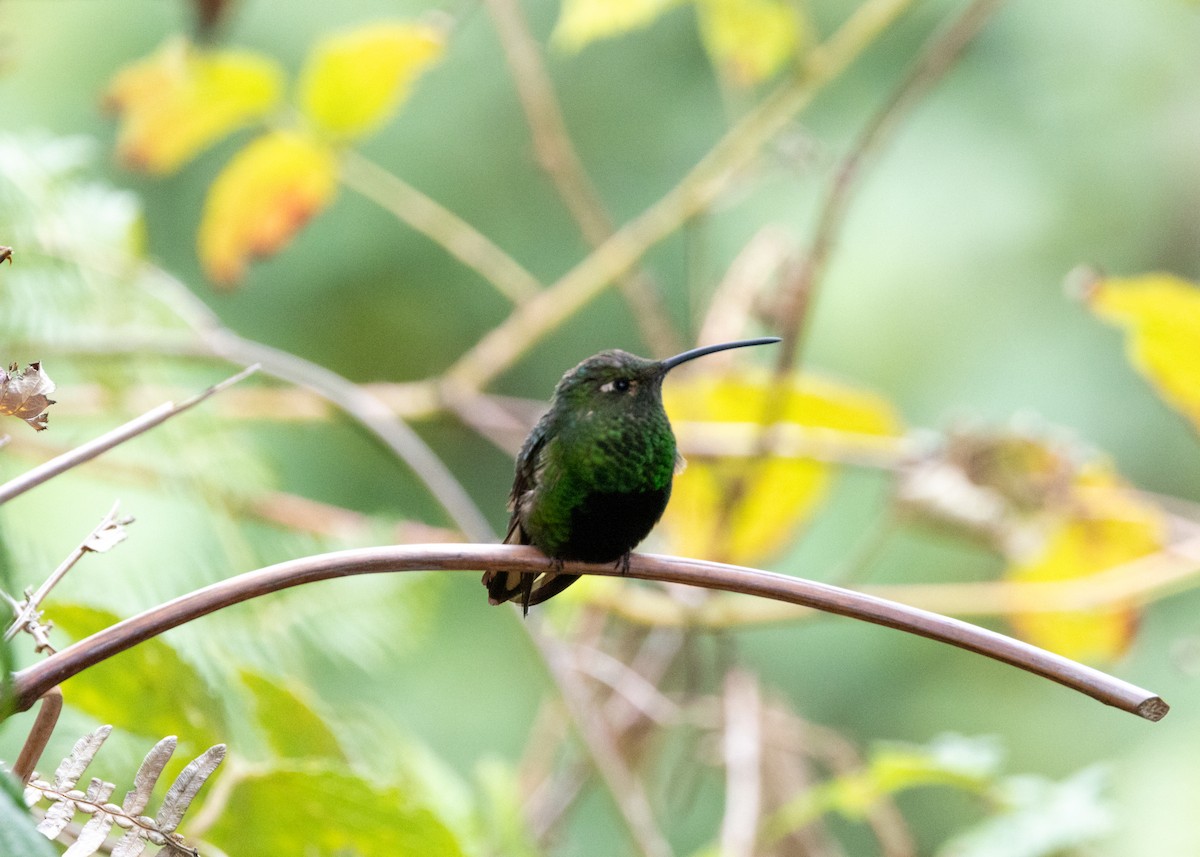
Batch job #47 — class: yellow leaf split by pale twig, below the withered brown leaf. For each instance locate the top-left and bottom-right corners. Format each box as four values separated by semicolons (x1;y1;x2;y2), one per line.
1006;462;1166;661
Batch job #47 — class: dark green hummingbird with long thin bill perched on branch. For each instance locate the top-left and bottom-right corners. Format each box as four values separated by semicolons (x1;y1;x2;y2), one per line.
484;336;779;615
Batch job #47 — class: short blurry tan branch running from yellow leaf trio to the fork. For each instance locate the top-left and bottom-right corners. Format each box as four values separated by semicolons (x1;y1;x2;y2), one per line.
342;149;542;305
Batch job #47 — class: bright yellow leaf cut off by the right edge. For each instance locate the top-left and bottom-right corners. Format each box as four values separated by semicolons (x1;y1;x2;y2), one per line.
1088;274;1200;431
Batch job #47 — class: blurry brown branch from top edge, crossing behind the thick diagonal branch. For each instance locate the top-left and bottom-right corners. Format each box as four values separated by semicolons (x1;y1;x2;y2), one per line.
486;0;683;356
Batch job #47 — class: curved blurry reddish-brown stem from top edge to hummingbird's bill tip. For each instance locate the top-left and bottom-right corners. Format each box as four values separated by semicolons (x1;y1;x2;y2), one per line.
776;0;1003;373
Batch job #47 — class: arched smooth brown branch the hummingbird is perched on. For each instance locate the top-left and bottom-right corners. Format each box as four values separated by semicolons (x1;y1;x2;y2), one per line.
12;545;1168;720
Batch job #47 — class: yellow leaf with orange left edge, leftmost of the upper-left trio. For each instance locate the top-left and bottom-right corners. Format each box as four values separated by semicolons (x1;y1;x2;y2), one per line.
104;38;283;174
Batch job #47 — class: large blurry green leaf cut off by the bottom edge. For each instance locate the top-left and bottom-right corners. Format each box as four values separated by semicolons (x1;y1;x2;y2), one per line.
205;765;466;857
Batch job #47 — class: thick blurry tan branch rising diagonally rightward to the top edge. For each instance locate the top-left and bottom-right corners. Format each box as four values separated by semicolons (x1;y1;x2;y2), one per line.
445;0;912;390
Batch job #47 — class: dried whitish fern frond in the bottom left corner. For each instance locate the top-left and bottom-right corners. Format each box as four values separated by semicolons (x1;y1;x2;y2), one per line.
25;726;226;857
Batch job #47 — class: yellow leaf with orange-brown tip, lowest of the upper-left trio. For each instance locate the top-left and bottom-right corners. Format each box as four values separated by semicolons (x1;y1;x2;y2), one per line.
198;131;337;286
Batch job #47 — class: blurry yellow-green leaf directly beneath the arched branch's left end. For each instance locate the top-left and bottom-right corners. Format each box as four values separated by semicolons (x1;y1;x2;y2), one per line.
47;604;227;748
